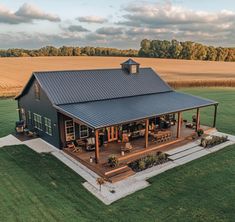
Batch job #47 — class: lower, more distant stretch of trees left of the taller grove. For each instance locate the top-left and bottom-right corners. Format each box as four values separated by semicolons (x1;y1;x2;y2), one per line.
0;46;138;57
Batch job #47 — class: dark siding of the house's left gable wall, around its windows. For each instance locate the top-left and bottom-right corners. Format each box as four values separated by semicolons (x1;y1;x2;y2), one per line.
18;79;60;148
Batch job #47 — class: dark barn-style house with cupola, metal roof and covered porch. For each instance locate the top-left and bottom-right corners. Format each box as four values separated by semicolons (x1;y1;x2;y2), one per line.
16;59;218;182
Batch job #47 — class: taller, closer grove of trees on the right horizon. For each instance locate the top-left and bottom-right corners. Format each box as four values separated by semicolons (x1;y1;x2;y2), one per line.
138;39;235;61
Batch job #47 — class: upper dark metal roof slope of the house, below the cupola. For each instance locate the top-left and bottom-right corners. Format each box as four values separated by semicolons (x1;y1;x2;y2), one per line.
34;68;172;105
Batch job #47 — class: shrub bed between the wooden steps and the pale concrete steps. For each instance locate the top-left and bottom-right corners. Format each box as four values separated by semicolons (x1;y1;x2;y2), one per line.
128;152;169;172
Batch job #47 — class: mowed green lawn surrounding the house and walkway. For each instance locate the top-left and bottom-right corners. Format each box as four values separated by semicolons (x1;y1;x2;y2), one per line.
0;89;235;222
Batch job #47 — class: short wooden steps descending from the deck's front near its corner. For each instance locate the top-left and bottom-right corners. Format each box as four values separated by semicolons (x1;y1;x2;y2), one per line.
107;166;135;183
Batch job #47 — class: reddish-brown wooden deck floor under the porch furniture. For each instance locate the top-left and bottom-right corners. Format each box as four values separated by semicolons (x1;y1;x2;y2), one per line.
64;126;209;182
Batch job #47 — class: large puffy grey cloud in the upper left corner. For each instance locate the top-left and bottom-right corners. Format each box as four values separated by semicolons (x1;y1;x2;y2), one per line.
0;3;60;24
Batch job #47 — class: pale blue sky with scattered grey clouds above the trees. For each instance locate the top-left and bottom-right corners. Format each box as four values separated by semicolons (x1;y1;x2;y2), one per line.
0;0;235;49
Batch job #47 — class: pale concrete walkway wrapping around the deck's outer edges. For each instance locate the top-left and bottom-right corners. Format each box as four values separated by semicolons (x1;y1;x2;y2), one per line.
0;132;235;205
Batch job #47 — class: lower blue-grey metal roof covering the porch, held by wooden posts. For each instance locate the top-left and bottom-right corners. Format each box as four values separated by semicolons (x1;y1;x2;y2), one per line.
55;91;217;129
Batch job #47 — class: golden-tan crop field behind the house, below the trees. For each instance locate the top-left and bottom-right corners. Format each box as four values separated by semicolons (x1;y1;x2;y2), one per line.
0;57;235;96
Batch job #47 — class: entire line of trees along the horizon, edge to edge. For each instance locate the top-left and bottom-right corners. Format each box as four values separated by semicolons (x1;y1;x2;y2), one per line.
0;39;235;61
